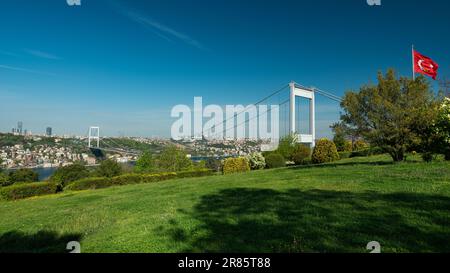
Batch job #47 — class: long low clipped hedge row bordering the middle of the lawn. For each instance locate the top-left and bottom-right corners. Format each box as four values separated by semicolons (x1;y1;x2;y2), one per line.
64;169;213;191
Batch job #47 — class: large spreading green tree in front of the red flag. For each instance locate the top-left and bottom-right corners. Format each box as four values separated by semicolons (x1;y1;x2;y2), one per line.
341;69;436;162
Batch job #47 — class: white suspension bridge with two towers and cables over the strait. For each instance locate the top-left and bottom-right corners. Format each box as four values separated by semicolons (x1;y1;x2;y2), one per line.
88;79;342;156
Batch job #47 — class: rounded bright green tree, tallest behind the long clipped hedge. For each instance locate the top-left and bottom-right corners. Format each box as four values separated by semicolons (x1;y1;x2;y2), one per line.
157;145;193;172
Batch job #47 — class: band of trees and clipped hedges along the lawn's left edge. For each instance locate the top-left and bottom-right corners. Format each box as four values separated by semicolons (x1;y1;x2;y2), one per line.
0;145;213;200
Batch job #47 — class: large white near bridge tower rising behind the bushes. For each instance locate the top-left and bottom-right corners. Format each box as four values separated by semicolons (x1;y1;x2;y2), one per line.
289;82;316;148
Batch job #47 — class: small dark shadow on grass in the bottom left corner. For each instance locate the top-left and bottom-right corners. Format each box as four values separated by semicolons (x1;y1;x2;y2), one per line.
0;231;81;253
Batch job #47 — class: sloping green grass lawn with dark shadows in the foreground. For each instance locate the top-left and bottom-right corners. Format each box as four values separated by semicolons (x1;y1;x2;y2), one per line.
0;156;450;252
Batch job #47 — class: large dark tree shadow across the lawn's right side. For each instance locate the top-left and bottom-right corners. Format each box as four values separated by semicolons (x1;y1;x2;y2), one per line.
158;188;450;252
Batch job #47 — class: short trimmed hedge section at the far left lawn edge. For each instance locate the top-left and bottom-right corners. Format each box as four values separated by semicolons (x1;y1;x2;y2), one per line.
0;182;56;200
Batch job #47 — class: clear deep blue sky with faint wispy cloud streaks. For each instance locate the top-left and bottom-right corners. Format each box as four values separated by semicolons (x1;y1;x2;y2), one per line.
0;0;450;137
